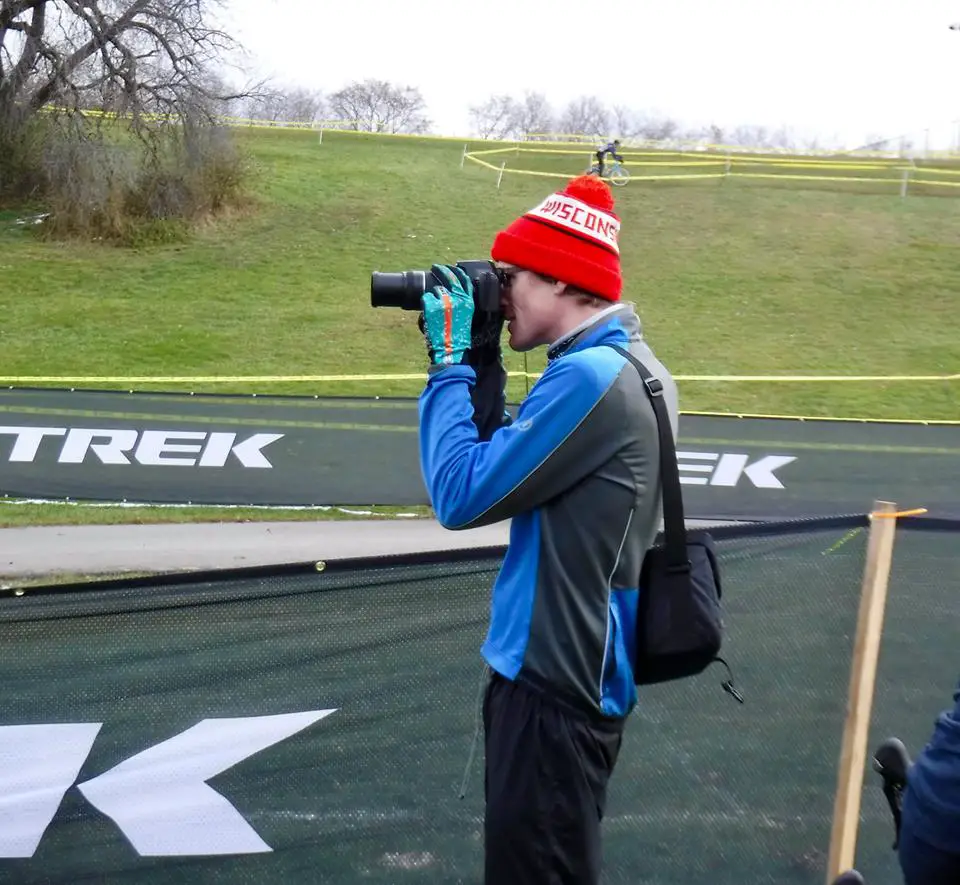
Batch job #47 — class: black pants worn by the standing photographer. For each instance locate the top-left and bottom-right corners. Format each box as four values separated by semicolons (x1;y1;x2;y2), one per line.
483;674;624;885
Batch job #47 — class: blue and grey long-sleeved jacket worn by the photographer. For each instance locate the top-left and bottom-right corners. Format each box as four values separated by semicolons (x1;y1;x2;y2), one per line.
420;304;677;717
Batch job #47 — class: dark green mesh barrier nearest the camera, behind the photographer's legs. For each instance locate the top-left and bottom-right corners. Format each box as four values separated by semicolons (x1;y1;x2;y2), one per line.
0;516;960;885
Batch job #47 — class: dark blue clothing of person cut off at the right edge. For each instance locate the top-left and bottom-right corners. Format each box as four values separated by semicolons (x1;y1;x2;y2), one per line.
903;672;960;855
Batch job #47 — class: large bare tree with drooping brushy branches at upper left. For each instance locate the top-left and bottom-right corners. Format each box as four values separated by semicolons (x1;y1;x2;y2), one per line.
0;0;253;235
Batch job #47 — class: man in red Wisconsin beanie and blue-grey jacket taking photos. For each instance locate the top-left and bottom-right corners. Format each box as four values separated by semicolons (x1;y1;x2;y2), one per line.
420;176;677;885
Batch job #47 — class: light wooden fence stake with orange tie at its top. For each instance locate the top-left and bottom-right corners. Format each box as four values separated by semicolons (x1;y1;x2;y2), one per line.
827;501;897;883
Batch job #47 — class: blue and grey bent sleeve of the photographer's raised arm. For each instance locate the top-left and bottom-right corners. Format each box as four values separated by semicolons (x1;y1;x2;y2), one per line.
420;348;624;529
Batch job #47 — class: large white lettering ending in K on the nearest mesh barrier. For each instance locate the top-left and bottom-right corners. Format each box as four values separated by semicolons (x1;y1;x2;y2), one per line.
0;710;336;857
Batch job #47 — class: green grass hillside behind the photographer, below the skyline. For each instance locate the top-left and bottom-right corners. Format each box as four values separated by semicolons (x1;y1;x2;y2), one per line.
0;130;960;520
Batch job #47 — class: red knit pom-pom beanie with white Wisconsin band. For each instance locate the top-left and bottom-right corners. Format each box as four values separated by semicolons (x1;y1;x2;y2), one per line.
490;175;623;301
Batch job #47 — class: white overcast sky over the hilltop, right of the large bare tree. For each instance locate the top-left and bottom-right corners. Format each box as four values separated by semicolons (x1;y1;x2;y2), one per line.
225;0;960;147
